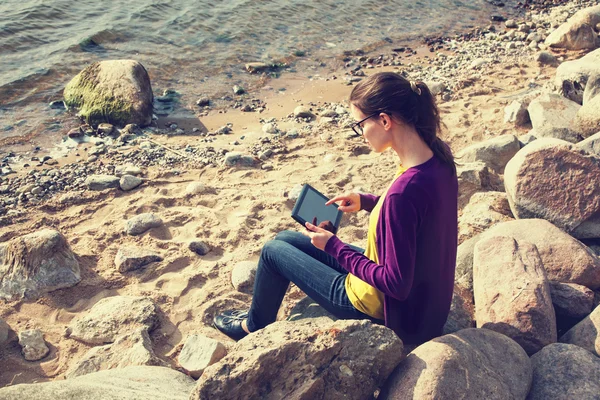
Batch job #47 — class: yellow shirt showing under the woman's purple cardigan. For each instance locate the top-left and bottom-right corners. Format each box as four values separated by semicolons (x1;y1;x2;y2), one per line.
345;166;406;319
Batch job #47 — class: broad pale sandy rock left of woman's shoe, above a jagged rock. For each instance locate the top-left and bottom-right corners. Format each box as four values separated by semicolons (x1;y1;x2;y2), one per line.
69;296;158;345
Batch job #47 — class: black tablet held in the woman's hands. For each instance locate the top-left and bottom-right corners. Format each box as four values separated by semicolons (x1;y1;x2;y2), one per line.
292;184;343;233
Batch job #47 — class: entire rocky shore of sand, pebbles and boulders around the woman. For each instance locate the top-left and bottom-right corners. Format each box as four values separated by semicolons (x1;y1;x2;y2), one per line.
0;1;600;399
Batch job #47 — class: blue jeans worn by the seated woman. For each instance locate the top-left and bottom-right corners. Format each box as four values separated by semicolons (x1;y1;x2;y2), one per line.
247;231;382;332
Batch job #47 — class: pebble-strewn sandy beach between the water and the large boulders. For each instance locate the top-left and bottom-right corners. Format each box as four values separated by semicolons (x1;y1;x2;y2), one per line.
0;2;589;387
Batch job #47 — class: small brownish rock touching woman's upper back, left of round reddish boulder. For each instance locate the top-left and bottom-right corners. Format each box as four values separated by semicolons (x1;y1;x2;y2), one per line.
457;162;502;209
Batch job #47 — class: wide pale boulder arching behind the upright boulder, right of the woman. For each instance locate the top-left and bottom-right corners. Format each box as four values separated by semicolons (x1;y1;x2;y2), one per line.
456;219;600;289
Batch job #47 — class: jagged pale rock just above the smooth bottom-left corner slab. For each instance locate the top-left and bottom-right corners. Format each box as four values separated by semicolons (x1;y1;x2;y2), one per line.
66;329;168;379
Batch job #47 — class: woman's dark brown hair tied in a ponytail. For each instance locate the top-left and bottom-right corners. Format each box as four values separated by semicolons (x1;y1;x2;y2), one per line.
350;72;456;175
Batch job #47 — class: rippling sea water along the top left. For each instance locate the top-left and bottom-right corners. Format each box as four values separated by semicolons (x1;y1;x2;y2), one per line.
0;0;511;148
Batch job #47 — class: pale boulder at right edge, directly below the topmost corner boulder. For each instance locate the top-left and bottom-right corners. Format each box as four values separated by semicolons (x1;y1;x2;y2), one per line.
554;49;600;104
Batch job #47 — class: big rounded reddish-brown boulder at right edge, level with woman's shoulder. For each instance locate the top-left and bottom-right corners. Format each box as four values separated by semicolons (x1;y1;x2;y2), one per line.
504;138;600;238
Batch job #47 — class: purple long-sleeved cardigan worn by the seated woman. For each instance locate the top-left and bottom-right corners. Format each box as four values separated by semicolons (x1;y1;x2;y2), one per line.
325;156;458;343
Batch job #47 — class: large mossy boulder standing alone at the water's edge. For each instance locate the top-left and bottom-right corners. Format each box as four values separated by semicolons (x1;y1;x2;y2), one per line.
64;60;154;126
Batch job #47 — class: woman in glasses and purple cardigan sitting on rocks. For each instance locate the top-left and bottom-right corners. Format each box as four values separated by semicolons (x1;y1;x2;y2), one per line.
215;73;458;344
